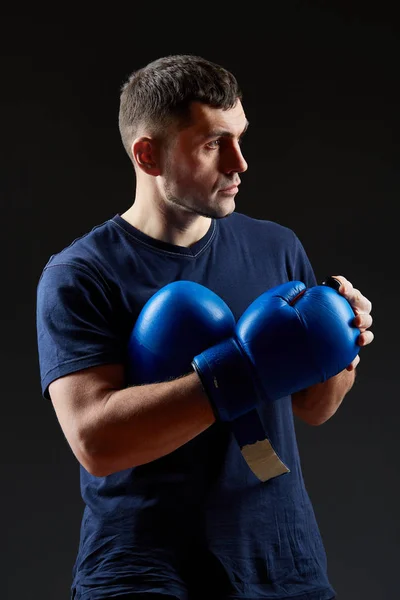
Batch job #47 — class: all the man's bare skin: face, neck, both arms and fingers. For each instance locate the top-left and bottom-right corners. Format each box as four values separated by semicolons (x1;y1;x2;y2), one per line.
49;101;374;477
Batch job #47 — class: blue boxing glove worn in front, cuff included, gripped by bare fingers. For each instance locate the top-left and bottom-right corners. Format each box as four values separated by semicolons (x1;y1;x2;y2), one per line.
192;281;360;421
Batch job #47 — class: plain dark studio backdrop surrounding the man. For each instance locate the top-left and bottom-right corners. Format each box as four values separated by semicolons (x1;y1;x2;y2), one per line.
0;1;400;600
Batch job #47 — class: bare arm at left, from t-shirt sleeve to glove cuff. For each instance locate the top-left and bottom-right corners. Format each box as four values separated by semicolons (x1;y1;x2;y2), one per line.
49;365;215;477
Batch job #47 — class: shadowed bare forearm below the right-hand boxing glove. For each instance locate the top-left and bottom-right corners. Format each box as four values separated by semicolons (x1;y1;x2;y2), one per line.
292;369;356;425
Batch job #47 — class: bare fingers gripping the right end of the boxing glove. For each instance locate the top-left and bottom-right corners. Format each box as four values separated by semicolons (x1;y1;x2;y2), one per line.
326;275;374;371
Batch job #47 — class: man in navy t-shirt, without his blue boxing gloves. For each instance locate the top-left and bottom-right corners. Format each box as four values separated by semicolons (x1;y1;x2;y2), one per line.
37;56;373;600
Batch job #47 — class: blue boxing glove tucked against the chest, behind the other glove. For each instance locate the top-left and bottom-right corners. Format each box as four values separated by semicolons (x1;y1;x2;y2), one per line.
127;281;266;469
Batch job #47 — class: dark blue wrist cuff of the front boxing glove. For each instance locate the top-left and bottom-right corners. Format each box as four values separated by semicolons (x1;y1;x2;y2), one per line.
192;338;257;421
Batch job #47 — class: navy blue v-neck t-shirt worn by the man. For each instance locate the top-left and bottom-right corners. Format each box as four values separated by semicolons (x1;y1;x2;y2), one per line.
37;212;334;600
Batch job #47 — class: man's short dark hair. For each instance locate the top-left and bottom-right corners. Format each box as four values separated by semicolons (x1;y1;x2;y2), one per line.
115;54;242;160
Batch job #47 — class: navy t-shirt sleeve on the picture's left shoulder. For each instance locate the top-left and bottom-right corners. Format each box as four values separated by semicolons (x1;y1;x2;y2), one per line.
36;264;124;399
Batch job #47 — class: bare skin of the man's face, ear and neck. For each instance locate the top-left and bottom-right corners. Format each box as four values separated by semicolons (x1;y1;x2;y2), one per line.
122;102;248;247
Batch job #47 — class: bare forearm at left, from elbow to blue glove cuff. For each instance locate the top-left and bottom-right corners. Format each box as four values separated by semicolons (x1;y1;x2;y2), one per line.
87;373;215;476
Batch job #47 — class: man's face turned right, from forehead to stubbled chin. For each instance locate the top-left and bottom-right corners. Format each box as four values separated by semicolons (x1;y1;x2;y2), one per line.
158;100;248;218
